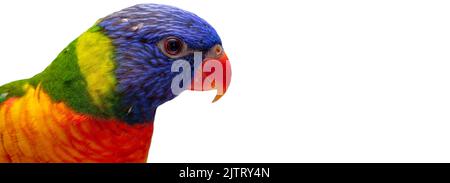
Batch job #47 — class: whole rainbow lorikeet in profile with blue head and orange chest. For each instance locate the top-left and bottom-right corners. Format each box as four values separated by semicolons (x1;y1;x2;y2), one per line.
0;4;231;162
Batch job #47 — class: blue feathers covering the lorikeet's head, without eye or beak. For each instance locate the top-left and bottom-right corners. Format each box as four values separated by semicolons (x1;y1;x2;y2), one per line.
98;4;221;124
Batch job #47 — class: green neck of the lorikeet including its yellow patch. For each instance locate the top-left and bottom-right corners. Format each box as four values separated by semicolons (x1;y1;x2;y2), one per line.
23;26;132;122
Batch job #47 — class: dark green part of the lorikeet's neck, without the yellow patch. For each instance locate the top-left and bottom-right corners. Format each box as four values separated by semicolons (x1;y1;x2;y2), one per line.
27;38;117;118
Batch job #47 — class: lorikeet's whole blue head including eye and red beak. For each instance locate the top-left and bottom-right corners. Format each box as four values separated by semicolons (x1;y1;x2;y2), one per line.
89;4;231;123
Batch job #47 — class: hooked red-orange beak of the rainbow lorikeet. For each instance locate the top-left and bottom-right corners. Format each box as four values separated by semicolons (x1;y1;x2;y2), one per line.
188;45;231;103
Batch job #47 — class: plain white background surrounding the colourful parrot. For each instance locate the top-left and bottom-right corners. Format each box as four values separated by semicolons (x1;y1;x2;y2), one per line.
0;0;450;162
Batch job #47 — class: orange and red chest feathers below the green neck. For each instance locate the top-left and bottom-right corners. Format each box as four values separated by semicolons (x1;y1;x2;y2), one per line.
0;88;153;163
